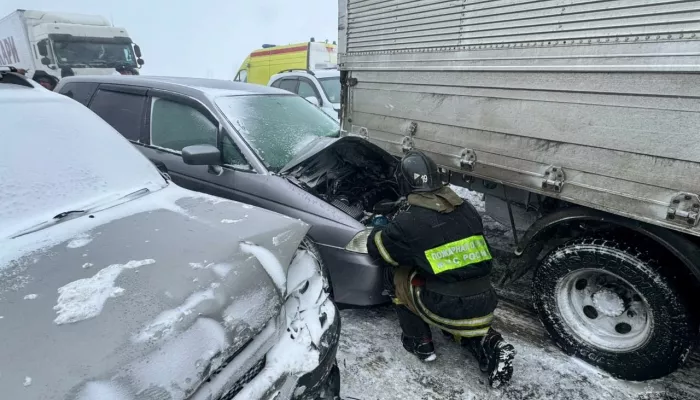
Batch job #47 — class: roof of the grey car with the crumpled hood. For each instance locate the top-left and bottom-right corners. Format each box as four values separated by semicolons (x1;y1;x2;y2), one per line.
59;75;290;97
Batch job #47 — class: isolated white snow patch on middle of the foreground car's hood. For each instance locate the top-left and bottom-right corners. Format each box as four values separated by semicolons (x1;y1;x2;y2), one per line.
54;259;155;325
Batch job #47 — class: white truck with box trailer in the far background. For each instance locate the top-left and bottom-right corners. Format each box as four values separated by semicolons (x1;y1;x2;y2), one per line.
0;10;144;79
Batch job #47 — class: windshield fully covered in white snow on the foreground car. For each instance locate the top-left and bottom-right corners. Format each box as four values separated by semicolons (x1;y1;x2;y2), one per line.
0;95;167;238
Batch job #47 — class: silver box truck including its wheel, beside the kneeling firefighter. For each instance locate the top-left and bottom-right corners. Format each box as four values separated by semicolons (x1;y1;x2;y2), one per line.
338;0;700;380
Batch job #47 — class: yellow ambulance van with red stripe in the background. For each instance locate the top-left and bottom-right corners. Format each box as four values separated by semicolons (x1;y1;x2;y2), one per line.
233;38;338;85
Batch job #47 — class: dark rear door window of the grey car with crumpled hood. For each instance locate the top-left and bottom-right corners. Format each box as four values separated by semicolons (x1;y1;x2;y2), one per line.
90;90;146;142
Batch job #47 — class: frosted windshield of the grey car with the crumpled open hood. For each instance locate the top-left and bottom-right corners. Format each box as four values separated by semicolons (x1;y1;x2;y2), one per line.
216;95;339;172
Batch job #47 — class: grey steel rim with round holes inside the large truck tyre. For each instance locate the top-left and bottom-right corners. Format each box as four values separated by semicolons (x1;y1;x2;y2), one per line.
556;269;654;353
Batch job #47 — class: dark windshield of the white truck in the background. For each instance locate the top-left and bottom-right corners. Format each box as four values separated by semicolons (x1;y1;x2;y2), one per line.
53;41;136;67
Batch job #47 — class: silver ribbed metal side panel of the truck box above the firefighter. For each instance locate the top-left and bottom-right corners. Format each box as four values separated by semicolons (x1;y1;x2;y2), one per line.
339;0;700;235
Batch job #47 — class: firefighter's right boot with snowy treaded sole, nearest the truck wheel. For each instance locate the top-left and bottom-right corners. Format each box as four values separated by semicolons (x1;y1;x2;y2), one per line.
464;328;516;388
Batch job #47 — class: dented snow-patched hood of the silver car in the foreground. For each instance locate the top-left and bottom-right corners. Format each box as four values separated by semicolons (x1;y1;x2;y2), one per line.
0;185;308;399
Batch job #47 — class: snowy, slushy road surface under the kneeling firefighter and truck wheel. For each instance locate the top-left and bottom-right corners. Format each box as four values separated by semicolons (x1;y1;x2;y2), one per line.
338;190;700;400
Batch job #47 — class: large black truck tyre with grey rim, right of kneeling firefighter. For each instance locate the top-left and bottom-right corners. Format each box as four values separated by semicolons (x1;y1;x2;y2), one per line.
533;238;698;381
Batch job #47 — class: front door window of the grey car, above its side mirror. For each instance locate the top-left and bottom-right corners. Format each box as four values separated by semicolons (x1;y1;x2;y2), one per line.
151;98;217;151
